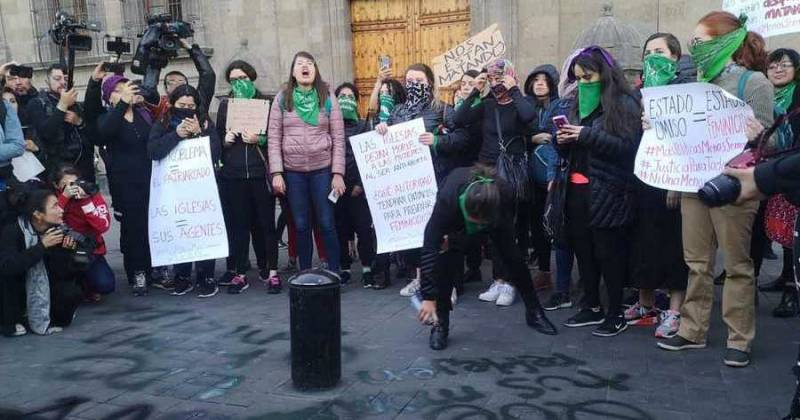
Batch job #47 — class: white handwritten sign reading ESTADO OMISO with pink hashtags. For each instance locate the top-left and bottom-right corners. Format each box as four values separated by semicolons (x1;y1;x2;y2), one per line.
634;83;753;192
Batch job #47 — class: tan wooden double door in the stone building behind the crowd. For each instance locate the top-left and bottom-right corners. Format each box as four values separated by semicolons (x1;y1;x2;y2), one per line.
350;0;470;115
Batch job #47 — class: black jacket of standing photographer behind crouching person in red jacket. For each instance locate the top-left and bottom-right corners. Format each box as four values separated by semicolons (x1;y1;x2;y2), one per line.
26;91;96;181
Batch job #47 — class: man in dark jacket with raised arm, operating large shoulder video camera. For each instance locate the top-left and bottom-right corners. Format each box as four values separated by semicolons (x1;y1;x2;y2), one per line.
153;39;217;119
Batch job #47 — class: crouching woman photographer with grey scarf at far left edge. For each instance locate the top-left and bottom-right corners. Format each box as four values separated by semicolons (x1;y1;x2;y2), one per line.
0;185;80;336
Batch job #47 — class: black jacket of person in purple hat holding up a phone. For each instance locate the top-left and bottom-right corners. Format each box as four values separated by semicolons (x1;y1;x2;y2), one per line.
97;101;152;183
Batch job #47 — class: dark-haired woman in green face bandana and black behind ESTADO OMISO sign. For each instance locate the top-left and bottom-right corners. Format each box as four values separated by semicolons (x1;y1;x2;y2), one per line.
625;33;697;338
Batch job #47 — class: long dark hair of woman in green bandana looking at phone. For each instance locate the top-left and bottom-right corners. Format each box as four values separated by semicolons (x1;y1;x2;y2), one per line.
570;47;641;136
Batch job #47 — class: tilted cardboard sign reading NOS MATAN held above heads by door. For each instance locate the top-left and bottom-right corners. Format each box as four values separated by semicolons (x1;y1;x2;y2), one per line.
431;23;506;86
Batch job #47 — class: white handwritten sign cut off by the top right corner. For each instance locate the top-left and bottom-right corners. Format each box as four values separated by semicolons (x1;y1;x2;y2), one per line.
722;0;800;38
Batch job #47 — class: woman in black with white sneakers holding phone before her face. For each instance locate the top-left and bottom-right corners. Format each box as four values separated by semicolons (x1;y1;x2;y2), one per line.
454;59;536;306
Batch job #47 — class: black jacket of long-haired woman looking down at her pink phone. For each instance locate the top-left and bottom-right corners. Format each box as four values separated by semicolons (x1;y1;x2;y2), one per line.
557;96;642;228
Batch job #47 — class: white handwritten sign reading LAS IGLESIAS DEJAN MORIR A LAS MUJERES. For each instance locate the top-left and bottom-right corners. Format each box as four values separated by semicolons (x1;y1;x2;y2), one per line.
350;118;438;254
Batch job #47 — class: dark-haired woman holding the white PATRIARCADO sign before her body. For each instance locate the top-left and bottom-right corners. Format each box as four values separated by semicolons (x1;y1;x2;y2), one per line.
147;85;221;298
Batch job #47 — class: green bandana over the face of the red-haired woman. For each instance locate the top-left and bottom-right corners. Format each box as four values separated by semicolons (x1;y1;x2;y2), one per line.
689;25;747;82
